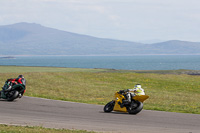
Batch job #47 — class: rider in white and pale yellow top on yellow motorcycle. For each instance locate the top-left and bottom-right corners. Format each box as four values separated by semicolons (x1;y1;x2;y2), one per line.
119;84;145;103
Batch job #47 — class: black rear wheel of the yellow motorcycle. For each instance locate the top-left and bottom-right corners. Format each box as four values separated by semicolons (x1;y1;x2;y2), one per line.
127;101;143;114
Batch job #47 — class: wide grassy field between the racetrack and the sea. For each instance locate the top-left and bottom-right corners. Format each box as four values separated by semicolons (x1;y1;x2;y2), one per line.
0;66;200;114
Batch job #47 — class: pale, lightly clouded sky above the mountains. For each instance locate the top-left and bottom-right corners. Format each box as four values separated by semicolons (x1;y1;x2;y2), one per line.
0;0;200;43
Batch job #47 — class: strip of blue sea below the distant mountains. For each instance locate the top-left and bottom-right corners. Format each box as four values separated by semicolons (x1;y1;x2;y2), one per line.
0;55;200;70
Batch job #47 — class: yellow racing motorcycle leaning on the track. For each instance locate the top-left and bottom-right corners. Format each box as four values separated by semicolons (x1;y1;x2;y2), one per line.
104;92;149;114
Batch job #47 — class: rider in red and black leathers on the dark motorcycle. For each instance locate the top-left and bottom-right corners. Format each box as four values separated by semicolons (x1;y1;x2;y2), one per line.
0;75;26;98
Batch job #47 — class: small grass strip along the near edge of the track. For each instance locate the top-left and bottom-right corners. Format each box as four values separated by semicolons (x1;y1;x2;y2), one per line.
0;125;94;133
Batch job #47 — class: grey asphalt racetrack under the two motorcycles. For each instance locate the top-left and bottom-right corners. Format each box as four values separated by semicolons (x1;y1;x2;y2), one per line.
0;96;200;133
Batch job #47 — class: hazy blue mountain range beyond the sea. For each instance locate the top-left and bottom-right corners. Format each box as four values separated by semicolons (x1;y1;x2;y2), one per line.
0;22;200;55
